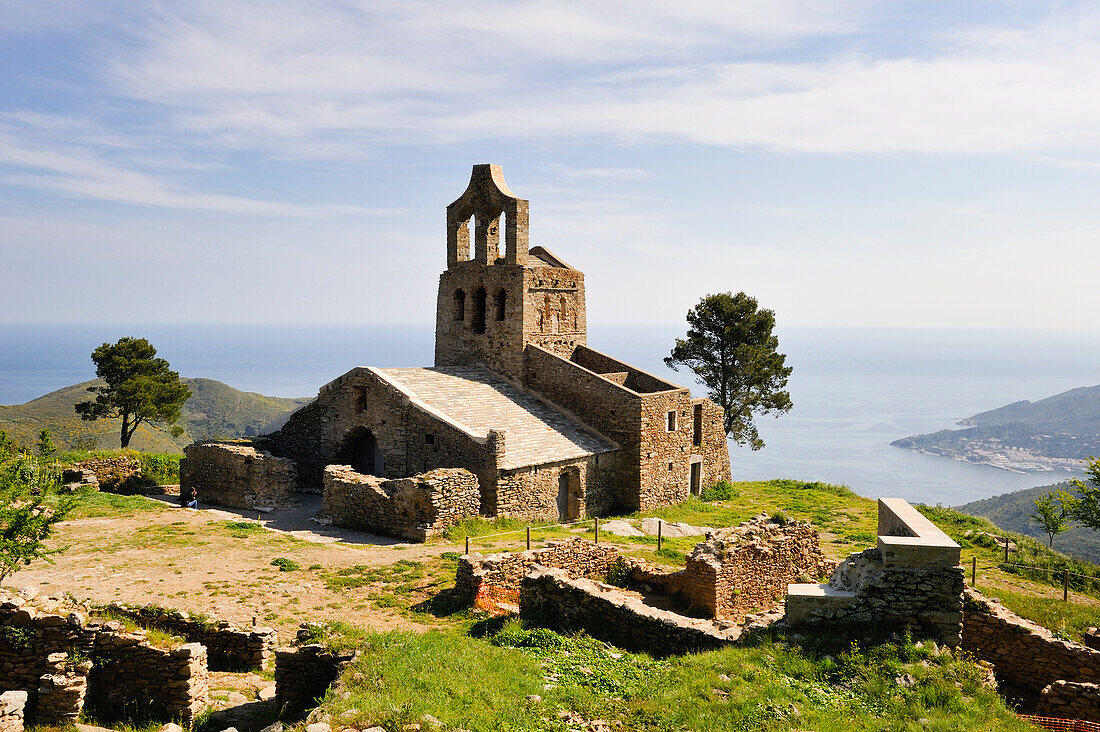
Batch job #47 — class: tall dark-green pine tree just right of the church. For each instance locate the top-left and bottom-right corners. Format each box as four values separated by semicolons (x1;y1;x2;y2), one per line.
664;293;793;450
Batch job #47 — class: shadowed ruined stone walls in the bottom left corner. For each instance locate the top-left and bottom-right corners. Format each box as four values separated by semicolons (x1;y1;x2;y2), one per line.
0;593;209;723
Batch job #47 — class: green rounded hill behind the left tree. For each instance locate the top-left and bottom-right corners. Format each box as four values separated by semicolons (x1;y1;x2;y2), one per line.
0;379;309;452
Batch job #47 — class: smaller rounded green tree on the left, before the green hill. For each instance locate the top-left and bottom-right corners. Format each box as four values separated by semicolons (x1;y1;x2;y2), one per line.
76;338;191;447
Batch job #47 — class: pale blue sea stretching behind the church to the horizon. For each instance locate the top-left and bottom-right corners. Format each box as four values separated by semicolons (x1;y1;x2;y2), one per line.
0;325;1100;505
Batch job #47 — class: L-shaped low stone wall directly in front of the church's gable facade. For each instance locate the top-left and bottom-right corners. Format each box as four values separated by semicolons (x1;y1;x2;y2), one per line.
318;466;481;542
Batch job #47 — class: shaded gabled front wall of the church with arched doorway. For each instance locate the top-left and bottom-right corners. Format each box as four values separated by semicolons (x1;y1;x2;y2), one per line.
262;368;496;494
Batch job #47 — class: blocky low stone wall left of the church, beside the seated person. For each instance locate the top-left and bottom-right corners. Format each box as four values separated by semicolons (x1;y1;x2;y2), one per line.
179;443;297;509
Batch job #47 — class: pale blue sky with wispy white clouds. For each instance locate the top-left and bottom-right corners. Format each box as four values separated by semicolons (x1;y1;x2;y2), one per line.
0;0;1100;330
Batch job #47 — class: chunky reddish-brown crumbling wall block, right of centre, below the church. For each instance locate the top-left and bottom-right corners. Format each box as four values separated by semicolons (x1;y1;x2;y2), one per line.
681;514;832;619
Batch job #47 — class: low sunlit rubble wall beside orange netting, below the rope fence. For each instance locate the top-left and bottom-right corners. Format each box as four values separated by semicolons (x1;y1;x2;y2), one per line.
454;538;619;602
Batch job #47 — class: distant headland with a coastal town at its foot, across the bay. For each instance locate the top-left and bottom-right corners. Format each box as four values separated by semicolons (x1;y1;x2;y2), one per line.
891;385;1100;472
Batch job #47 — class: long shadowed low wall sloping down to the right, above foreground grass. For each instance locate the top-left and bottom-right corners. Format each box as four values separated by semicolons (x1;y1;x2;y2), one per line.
519;567;741;656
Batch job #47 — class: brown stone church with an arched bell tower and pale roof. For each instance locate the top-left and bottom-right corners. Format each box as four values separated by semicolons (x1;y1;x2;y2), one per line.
264;165;730;521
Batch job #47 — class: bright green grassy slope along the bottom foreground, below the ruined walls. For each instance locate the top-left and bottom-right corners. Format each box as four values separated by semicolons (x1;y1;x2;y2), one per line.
322;622;1030;732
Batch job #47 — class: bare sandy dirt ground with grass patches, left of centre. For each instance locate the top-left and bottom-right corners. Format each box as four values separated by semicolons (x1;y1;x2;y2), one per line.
7;502;455;640
